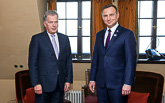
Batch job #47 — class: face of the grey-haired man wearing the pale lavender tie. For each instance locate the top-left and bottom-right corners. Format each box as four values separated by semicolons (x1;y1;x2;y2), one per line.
44;15;58;34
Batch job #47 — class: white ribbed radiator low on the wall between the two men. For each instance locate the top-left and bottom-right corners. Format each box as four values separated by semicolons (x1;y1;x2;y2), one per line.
65;90;82;103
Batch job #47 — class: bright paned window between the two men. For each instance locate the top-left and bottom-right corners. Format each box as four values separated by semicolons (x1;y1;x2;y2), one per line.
57;0;91;60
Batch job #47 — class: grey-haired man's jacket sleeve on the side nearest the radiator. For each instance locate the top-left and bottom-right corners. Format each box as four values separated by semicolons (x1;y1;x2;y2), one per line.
66;37;73;83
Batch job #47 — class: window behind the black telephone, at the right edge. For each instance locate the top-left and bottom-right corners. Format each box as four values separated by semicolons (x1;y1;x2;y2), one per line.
138;0;165;59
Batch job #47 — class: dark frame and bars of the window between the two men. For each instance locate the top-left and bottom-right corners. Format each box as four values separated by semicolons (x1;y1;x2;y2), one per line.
57;0;91;62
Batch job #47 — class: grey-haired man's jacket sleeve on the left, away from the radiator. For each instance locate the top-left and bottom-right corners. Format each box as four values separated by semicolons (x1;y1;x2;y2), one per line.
28;36;40;86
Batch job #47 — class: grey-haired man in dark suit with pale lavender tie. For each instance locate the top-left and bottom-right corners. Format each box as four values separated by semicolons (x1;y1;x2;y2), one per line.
28;10;73;103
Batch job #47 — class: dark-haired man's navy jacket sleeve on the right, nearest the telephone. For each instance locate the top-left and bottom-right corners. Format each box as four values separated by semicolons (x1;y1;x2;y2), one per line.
124;31;137;85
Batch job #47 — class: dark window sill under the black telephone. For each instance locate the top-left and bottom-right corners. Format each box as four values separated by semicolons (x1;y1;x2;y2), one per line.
137;59;165;64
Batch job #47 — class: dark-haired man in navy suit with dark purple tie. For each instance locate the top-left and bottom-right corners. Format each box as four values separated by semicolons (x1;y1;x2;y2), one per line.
89;5;137;103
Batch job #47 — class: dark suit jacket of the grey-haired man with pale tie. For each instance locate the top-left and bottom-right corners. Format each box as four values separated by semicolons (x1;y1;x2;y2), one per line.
28;31;73;92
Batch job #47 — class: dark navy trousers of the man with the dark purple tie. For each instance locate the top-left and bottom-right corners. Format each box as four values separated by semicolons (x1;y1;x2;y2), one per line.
97;87;128;103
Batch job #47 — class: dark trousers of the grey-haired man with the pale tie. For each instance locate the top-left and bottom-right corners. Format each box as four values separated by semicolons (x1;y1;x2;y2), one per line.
35;77;64;103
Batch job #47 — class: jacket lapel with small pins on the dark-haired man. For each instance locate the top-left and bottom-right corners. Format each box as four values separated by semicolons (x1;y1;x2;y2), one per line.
106;25;122;51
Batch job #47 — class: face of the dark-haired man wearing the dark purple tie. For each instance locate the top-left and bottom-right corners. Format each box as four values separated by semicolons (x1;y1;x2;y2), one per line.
102;7;119;29
